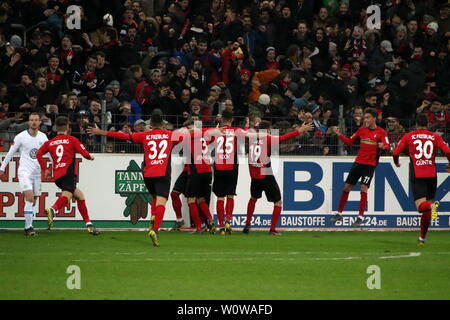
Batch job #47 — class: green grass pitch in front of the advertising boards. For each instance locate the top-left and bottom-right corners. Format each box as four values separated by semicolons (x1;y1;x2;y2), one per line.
0;230;450;299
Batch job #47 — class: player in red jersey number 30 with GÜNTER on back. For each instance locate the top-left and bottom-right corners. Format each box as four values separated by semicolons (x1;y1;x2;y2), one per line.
392;114;450;246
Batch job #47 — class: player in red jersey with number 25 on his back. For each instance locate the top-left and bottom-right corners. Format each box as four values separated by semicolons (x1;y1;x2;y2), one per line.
208;110;247;234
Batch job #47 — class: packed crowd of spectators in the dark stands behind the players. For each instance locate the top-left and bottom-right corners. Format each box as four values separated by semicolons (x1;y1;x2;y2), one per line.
0;0;450;155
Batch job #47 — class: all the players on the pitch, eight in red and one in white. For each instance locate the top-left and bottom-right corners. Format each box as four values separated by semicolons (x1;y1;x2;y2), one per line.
0;108;450;246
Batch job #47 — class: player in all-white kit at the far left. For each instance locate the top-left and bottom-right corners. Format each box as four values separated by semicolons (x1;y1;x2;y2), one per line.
0;113;48;236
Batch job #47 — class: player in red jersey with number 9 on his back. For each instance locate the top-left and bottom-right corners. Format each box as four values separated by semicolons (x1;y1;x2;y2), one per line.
36;117;100;235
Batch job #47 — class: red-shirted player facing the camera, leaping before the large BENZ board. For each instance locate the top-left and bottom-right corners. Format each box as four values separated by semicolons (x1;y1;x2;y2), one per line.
331;108;390;227
